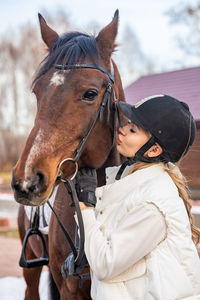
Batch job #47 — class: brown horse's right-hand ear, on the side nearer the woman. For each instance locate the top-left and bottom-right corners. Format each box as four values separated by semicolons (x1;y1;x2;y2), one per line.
96;9;119;63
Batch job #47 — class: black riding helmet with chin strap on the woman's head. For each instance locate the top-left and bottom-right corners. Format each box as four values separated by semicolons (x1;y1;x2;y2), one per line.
116;95;196;179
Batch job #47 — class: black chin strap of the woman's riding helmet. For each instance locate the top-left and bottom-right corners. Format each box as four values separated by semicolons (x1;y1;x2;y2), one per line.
115;136;167;180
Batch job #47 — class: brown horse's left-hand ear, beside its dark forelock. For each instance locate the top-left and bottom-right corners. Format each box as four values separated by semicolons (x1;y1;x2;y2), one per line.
38;14;58;48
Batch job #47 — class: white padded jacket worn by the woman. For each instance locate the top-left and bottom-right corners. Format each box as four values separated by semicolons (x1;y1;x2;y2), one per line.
82;164;200;300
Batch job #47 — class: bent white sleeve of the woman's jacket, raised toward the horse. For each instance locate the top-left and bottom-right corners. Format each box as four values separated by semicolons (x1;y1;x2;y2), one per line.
82;203;166;280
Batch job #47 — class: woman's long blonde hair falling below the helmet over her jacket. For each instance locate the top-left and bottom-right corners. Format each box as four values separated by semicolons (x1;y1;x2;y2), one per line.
131;162;200;246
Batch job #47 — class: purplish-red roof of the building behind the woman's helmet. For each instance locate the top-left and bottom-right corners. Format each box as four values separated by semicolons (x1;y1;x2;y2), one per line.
125;67;200;120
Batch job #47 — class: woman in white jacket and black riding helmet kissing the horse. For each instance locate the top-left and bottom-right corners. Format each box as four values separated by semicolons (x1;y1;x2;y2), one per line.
77;95;200;300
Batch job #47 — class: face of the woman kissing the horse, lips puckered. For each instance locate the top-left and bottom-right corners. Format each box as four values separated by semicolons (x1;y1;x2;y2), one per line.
117;121;150;157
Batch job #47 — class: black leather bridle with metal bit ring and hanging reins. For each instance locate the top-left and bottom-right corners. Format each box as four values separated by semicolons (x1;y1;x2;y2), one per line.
47;62;122;280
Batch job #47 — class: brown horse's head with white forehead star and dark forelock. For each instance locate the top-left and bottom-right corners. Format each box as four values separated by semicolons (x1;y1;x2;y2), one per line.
12;11;124;205
